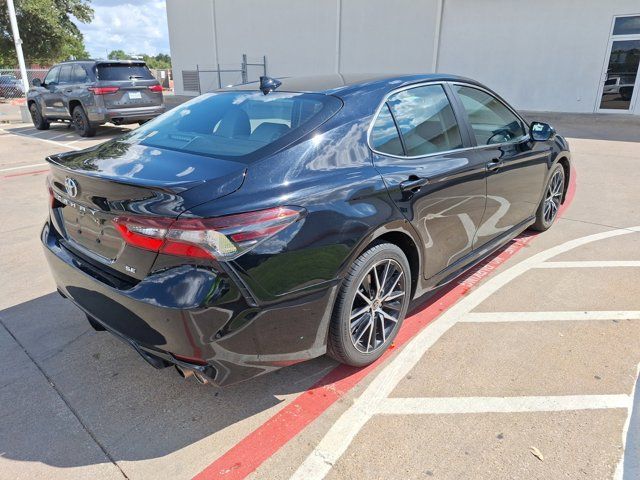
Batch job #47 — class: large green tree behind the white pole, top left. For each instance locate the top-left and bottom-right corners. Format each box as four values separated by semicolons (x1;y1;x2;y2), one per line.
0;0;93;66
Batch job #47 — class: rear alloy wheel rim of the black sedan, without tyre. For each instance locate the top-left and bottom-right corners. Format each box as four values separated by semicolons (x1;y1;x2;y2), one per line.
349;259;406;353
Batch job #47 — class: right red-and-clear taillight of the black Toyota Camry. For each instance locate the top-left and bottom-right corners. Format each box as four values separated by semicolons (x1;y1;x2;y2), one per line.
114;207;304;260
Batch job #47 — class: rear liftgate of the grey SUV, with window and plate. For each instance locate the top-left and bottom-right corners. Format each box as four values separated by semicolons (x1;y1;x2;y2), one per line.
96;63;162;109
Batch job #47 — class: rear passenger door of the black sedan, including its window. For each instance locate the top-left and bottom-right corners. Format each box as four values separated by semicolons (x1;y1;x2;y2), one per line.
370;83;486;278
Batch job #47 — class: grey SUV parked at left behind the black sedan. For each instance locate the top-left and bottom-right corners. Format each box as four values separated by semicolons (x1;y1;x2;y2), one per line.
27;60;165;137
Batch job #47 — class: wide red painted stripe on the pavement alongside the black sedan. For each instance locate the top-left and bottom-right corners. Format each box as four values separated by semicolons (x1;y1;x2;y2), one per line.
194;168;576;480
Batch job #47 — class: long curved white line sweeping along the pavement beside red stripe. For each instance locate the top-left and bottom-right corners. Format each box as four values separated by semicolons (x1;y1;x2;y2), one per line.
291;226;640;480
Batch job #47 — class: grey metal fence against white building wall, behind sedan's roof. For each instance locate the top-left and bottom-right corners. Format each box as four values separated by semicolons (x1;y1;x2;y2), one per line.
182;53;267;94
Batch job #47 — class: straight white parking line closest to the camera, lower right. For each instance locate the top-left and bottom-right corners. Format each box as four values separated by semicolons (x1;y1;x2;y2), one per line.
376;395;631;415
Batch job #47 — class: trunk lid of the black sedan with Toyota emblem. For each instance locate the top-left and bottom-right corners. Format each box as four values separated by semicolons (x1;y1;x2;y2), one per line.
47;141;245;279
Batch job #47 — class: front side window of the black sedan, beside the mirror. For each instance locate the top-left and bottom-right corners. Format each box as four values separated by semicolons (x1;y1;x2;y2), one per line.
454;85;525;145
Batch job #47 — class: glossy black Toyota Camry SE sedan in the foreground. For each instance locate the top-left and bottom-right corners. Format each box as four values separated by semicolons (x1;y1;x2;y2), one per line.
42;74;571;385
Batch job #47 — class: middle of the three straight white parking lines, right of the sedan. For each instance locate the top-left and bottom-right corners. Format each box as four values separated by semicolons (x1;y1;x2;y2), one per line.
460;310;640;323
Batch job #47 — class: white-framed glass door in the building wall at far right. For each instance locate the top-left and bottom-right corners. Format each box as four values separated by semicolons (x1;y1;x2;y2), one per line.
596;16;640;113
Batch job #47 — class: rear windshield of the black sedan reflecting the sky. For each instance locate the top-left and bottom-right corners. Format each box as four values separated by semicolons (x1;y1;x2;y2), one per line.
122;91;342;161
